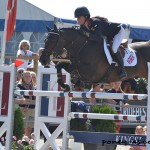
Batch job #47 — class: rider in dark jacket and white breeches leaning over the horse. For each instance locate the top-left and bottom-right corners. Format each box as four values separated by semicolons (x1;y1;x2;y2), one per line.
74;7;127;79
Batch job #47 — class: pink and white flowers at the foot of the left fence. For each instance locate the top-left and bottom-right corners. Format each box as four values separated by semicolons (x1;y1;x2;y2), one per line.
0;136;34;150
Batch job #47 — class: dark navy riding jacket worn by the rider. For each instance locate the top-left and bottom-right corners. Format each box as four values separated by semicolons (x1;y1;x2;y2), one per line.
81;18;121;42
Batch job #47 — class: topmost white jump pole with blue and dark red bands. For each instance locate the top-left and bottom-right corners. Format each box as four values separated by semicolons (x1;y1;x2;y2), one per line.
15;90;147;100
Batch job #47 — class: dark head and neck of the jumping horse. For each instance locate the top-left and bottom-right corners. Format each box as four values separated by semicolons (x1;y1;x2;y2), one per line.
40;25;85;65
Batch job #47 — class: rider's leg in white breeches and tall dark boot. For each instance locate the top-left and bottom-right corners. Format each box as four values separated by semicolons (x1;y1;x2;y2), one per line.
112;27;127;79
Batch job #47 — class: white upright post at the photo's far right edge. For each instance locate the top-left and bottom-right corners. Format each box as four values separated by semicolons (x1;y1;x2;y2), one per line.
146;63;150;150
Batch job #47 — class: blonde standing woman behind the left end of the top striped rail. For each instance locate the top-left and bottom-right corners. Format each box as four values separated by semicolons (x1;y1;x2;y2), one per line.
16;71;35;139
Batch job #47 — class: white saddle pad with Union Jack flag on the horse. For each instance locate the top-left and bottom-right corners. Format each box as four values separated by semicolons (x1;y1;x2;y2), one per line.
104;39;137;66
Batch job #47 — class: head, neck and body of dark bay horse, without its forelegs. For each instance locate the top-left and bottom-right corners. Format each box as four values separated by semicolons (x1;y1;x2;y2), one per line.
40;28;150;91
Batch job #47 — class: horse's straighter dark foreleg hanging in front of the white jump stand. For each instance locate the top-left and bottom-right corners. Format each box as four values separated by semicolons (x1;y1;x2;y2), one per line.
55;62;70;91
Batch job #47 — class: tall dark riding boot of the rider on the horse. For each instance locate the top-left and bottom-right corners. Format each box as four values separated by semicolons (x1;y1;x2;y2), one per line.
115;51;127;80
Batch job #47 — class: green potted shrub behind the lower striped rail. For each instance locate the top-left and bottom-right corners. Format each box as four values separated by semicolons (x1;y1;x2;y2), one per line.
84;105;117;150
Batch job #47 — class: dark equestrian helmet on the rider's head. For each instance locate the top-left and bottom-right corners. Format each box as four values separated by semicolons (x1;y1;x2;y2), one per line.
74;7;90;18
